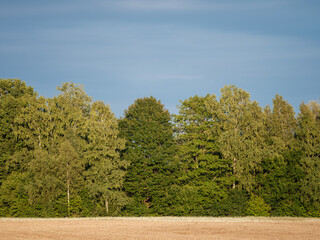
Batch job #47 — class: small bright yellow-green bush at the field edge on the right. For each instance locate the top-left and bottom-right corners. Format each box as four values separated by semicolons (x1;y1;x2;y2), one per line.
247;194;271;216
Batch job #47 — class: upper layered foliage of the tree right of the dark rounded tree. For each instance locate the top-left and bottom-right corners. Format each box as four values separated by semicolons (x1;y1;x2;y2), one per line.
175;95;229;187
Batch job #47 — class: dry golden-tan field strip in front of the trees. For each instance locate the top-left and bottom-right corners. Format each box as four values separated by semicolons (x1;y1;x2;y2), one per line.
0;217;320;240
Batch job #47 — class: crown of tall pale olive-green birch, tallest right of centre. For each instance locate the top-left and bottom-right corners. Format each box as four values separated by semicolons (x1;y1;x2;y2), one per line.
209;85;267;191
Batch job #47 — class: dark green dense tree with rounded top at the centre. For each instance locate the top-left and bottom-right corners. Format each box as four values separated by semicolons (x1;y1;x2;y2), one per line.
119;97;176;214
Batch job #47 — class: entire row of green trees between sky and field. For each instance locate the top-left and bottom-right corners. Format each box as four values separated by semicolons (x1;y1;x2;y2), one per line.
0;79;320;217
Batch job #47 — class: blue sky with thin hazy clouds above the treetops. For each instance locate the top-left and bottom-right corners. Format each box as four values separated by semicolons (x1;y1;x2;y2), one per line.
0;0;320;117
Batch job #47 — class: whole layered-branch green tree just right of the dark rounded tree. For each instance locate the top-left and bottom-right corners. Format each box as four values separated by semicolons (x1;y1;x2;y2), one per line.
174;95;230;215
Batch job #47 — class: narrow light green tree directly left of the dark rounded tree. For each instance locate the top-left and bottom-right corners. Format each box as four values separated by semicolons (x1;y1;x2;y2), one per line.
85;102;128;214
